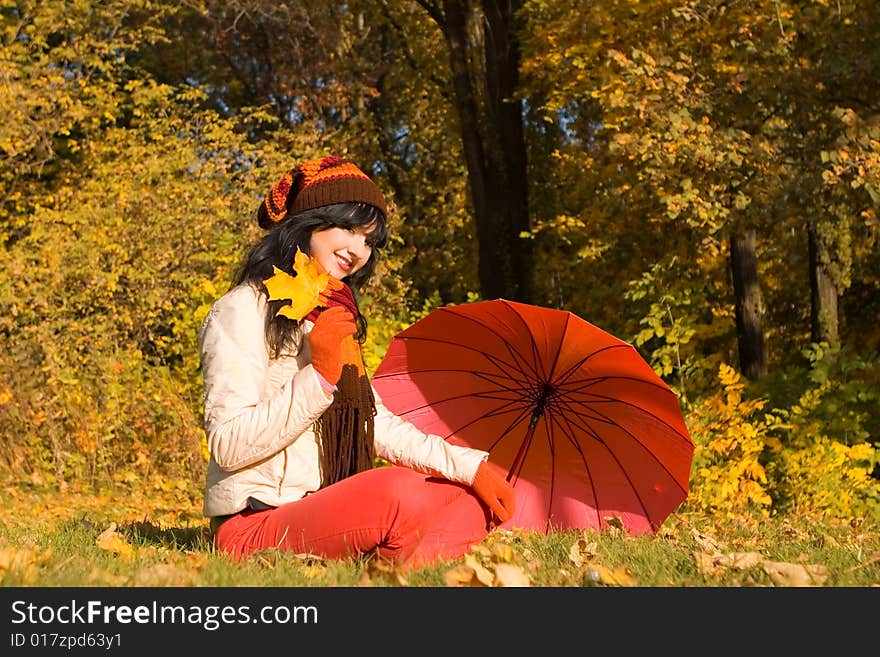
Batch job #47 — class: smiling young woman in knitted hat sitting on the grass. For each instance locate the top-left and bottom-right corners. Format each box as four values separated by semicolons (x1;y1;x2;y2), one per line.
199;157;514;568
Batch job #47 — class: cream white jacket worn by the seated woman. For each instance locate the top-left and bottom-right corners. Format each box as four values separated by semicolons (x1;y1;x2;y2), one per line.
199;285;488;516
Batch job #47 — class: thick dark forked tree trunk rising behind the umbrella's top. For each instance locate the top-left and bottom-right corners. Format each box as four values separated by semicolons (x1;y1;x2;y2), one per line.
432;0;533;302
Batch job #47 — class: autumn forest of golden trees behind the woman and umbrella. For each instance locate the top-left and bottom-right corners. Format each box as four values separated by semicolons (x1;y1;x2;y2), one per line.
0;0;880;560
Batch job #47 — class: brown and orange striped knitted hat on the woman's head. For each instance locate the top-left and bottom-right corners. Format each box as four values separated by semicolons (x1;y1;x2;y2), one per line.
257;156;388;228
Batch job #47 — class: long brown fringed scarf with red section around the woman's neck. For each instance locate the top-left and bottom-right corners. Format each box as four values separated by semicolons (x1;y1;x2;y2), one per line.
306;285;376;488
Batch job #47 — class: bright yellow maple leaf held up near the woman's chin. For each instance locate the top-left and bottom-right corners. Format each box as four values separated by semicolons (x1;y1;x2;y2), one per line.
263;249;344;322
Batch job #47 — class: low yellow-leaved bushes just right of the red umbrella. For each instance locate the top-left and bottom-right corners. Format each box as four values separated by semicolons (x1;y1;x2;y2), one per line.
689;358;880;518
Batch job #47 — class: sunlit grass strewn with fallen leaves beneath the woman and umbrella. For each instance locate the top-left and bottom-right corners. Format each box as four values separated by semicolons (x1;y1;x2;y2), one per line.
0;474;880;587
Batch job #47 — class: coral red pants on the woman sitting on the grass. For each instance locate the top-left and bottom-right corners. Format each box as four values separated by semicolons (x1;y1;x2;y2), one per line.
214;466;490;568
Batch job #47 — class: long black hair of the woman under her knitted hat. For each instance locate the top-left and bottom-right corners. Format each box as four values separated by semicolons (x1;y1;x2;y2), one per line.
232;203;388;356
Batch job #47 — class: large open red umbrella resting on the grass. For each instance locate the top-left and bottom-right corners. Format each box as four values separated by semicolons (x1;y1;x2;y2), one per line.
373;299;694;535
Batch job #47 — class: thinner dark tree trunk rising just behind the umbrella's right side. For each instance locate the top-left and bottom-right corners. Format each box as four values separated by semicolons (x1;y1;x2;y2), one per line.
730;228;767;381
